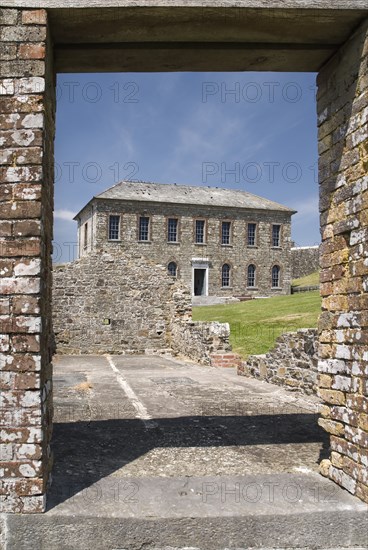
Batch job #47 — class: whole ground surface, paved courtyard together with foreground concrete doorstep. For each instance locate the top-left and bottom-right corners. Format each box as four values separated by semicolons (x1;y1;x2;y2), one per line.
3;356;367;550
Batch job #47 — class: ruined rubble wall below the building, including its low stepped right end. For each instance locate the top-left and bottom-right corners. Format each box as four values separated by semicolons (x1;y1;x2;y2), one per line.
53;252;231;364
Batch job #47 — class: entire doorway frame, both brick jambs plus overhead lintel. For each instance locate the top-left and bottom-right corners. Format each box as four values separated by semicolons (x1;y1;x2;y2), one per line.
0;0;368;512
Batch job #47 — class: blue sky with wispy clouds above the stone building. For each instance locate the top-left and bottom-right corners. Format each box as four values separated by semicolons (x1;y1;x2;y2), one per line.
54;72;320;262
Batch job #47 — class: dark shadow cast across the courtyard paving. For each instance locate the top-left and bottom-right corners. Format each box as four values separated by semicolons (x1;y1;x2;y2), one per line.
48;414;329;509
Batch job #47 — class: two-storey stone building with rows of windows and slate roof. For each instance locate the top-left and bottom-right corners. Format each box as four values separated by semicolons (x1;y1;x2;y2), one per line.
75;181;295;297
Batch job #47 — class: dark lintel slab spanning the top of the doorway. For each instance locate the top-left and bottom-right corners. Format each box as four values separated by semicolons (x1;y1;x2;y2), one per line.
2;0;368;73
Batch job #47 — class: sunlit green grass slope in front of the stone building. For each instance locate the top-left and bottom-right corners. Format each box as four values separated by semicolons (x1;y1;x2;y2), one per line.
193;291;321;357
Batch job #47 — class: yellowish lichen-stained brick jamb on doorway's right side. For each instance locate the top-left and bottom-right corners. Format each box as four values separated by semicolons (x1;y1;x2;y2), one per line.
318;21;368;502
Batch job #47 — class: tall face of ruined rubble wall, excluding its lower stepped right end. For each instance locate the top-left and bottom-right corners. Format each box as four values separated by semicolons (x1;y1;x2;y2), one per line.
53;253;180;354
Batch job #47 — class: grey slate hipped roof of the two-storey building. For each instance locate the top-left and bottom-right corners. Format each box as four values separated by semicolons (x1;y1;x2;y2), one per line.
76;181;296;217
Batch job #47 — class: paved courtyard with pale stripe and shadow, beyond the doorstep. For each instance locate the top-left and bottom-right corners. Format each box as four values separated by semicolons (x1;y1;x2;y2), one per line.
49;356;328;486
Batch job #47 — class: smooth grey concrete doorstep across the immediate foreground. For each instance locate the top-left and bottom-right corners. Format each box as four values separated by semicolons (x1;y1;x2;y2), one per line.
4;472;367;550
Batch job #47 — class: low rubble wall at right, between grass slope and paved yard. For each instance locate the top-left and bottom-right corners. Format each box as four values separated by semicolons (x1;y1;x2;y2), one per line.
238;329;318;394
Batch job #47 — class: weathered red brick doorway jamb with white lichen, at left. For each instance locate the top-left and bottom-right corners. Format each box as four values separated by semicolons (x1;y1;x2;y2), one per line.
0;9;55;513
